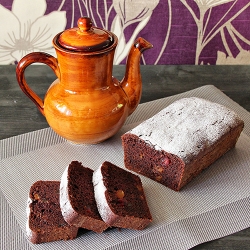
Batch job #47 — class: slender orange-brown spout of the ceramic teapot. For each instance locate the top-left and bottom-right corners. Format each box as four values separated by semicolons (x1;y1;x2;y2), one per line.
121;37;153;115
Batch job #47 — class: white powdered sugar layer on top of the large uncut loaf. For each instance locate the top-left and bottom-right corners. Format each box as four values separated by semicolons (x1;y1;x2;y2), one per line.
128;97;241;163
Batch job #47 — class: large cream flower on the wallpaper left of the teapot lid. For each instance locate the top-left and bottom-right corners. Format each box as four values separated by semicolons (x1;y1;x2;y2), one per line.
0;0;66;64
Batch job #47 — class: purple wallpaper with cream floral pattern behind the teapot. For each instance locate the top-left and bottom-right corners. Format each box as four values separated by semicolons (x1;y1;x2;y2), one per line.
0;0;250;65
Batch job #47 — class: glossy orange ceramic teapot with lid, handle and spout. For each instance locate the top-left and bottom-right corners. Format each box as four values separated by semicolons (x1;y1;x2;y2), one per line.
16;17;152;144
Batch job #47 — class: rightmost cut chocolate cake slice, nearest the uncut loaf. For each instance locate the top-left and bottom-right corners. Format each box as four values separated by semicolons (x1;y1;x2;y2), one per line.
93;162;152;230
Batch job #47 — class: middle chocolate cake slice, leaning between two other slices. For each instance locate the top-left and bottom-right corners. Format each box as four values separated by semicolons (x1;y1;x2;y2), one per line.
60;161;108;233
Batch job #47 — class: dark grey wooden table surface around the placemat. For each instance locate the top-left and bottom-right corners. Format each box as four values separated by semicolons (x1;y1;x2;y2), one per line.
0;65;250;250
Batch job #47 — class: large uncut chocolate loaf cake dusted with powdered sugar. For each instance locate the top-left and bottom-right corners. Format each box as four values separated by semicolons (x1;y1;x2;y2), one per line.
122;97;244;191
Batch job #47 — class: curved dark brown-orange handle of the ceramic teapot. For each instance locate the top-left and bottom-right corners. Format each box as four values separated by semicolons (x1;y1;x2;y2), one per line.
16;52;60;115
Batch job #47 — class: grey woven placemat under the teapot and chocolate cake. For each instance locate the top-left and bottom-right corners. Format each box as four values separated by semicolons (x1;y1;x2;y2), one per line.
0;85;250;249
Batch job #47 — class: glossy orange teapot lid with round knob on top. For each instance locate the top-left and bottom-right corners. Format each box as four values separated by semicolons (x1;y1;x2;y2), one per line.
58;17;114;52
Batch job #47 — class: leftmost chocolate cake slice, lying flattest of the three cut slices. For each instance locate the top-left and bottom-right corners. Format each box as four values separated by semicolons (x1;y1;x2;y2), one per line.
26;181;78;244
